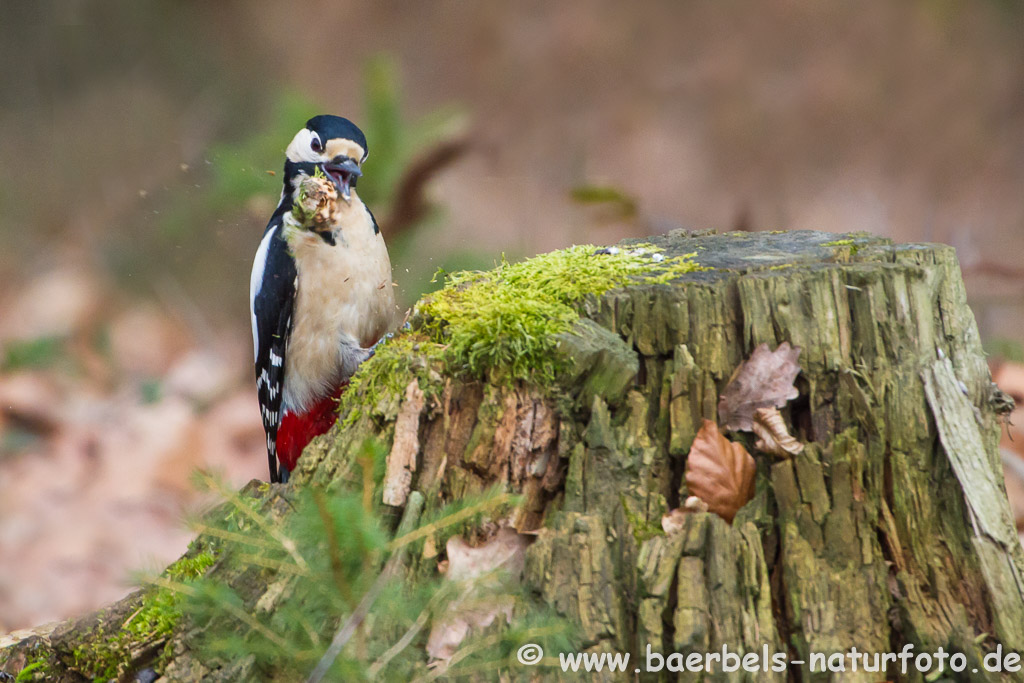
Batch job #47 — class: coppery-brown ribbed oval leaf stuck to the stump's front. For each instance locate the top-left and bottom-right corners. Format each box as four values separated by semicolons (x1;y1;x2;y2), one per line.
686;420;757;523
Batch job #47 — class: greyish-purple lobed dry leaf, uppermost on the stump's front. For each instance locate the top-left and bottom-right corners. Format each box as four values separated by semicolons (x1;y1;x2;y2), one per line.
718;342;800;431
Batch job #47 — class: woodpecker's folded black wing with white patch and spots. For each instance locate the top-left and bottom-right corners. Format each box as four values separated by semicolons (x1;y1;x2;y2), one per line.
249;218;296;481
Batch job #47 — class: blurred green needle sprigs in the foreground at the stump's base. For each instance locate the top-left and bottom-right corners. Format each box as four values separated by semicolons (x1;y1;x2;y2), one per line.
179;458;566;681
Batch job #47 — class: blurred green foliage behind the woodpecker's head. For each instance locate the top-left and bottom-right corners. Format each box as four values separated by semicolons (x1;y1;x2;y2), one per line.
136;55;463;310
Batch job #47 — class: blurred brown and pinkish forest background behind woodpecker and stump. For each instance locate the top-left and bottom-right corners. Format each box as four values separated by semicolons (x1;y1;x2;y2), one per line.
0;0;1024;633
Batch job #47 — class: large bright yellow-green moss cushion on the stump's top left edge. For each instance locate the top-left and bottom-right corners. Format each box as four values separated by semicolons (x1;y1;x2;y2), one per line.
338;244;700;427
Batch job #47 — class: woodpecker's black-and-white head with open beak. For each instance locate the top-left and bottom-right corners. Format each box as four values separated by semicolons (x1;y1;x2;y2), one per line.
285;114;370;202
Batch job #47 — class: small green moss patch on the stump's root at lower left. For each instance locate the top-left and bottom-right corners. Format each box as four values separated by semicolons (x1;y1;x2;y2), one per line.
71;551;216;681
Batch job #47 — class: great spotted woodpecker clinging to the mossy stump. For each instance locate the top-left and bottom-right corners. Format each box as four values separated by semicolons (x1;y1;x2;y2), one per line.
249;116;395;481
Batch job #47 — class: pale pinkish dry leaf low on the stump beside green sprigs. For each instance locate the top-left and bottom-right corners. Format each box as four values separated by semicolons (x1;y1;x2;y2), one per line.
427;526;529;659
